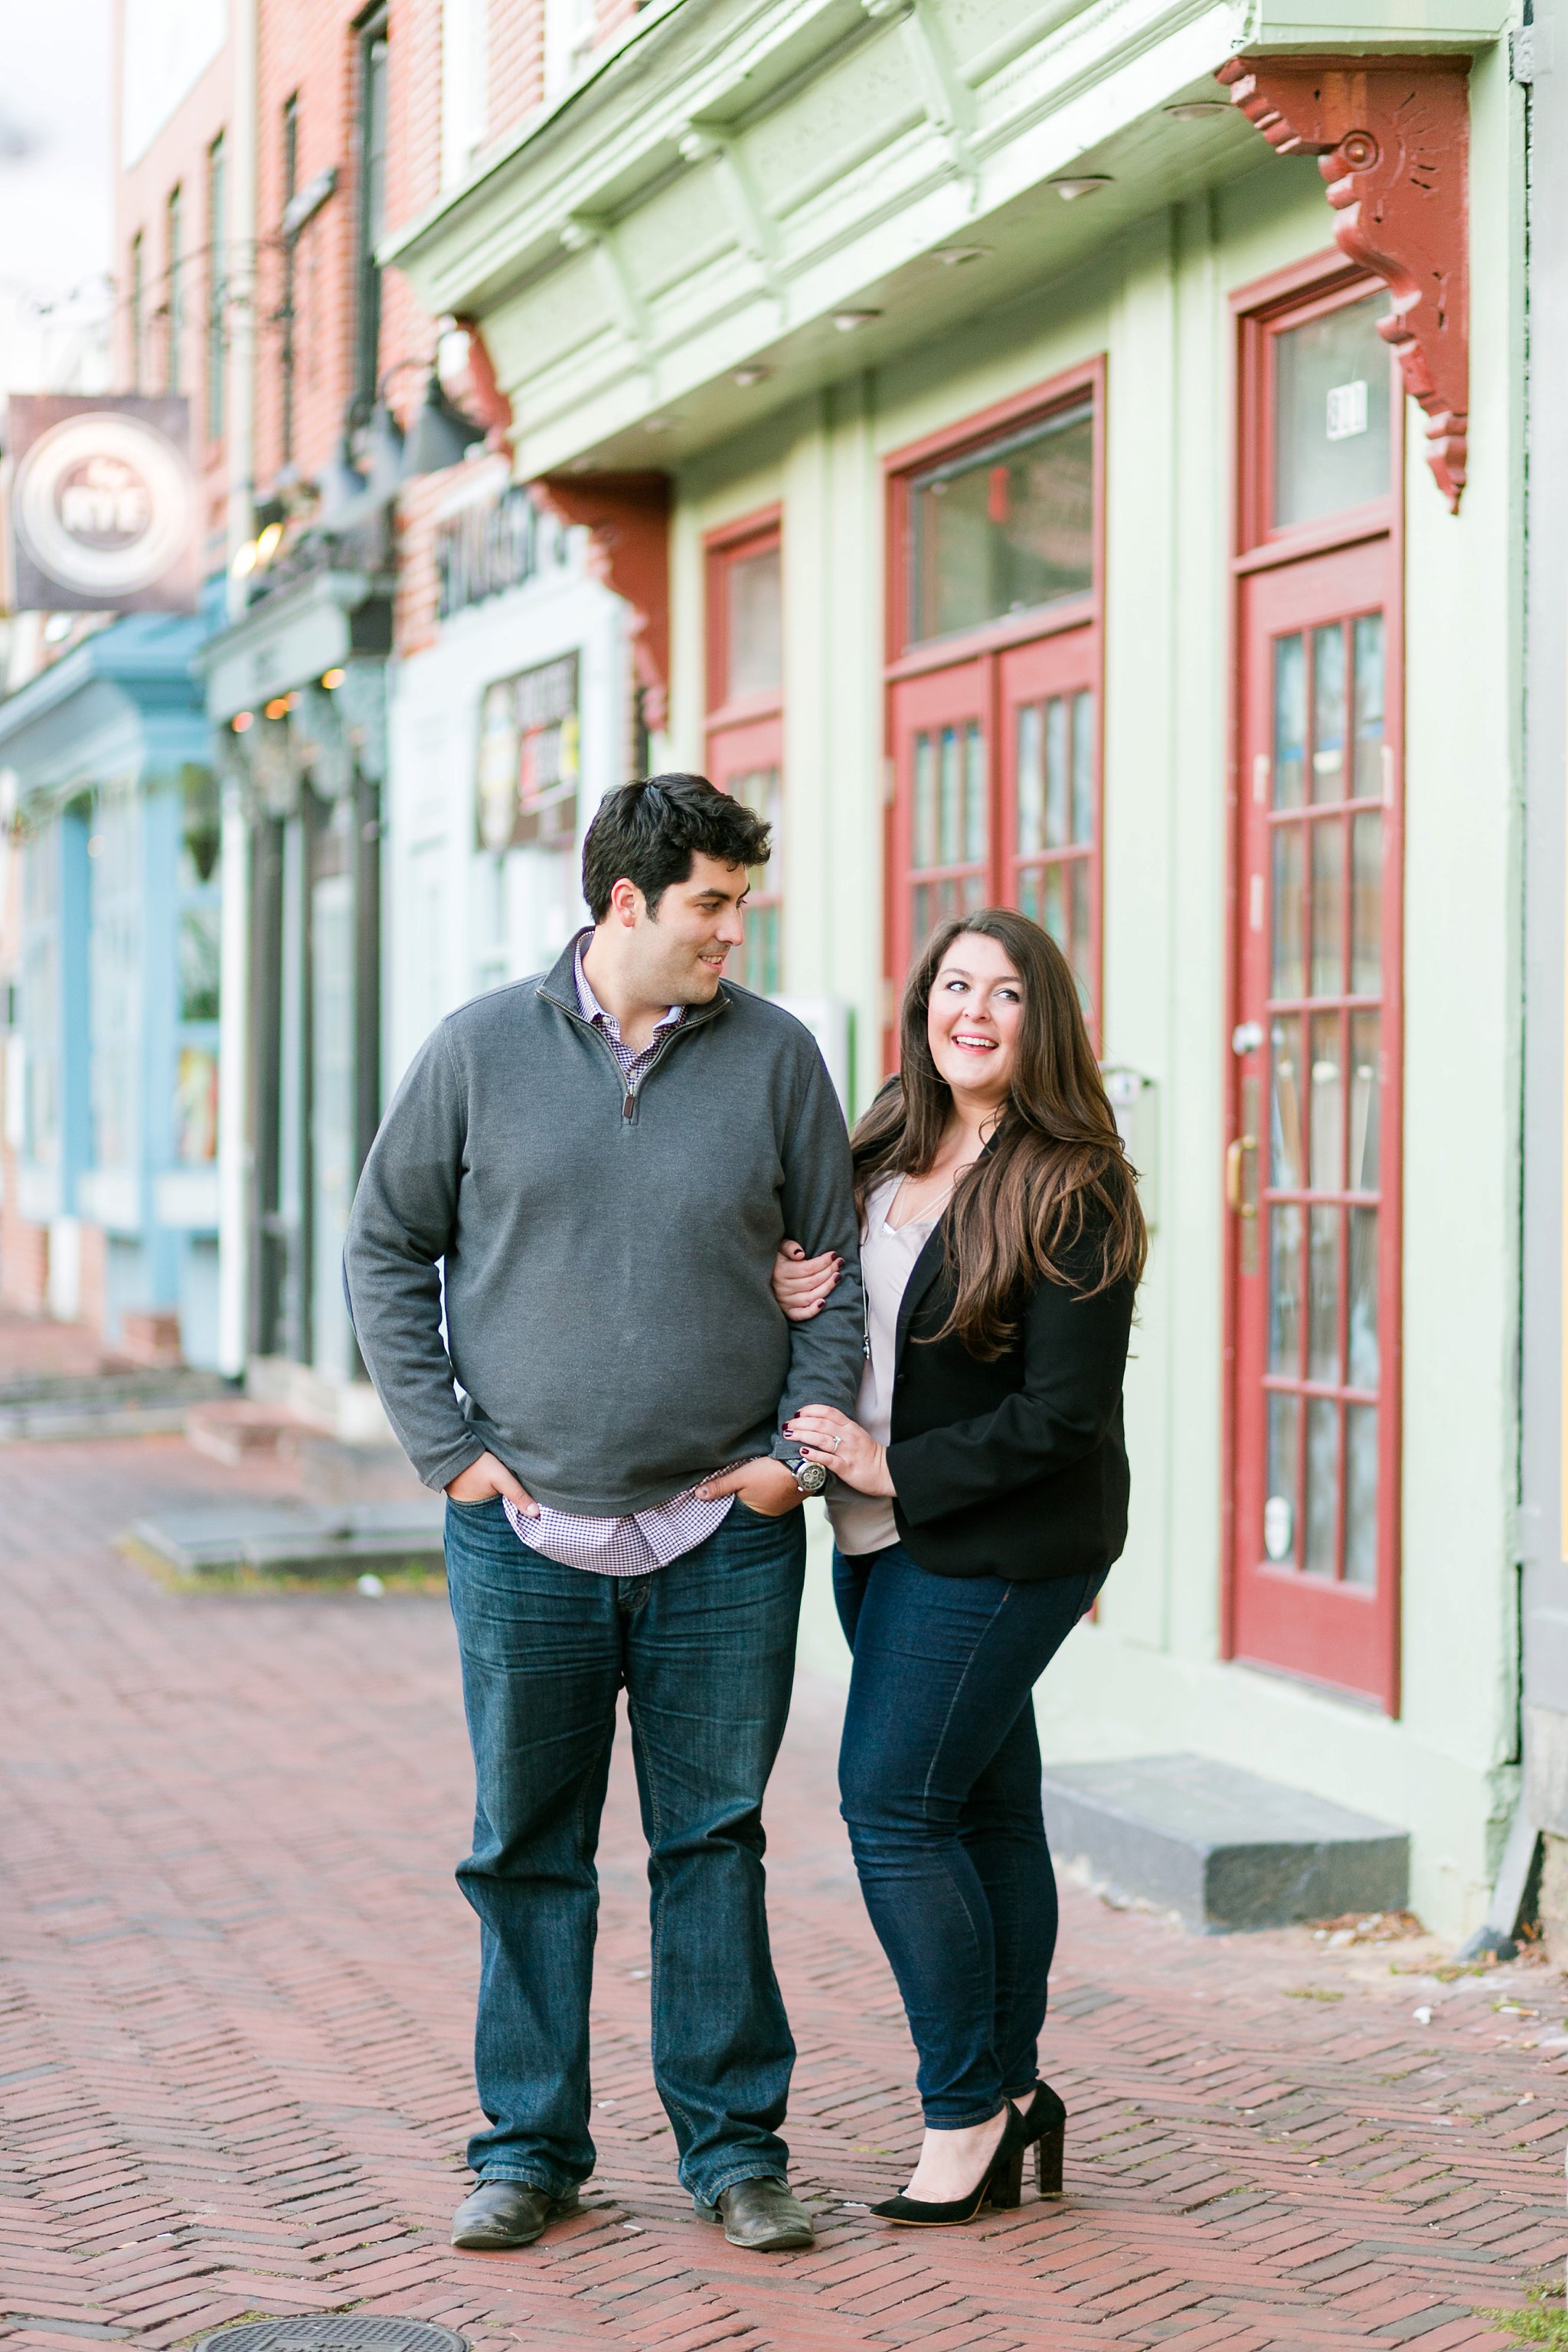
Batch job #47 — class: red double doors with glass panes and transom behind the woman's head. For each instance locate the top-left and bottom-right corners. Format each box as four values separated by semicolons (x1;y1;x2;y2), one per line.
889;369;1100;1021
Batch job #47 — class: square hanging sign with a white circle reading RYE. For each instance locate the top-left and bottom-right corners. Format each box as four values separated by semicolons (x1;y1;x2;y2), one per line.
5;393;198;612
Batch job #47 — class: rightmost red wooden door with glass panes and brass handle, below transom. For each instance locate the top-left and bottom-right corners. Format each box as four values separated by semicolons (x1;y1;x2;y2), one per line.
1227;538;1401;1712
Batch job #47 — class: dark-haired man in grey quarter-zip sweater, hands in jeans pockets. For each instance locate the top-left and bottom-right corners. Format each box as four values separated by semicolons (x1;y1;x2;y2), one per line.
345;776;863;2251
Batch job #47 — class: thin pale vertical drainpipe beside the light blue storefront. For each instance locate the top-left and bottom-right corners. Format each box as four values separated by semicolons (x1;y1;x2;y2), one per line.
219;0;261;1378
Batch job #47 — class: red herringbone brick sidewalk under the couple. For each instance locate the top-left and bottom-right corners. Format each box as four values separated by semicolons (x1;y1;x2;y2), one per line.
0;1439;1568;2352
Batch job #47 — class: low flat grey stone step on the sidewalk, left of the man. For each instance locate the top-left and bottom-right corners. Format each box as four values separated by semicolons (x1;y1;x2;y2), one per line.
127;1496;444;1580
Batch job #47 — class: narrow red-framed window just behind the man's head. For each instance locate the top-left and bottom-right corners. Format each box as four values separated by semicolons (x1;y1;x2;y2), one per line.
707;515;782;998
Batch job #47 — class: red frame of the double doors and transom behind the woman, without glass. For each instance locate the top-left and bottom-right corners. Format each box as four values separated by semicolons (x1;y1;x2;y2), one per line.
884;355;1105;1068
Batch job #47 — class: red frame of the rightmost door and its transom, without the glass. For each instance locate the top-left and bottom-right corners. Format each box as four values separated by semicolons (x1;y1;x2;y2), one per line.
1223;254;1403;1714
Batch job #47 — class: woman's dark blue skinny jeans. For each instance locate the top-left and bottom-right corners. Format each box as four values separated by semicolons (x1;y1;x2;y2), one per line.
832;1543;1102;2131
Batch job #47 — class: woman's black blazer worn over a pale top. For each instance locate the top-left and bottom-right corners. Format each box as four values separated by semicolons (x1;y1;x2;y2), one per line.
889;1220;1133;1583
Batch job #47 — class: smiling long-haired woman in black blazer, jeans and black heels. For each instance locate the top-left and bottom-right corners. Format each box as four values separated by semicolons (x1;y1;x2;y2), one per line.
773;908;1145;2225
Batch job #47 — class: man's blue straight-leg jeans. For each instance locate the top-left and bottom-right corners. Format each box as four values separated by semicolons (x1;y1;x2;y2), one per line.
446;1501;806;2203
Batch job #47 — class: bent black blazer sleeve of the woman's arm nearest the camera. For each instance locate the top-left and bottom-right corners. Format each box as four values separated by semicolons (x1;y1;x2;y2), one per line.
887;1251;1133;1527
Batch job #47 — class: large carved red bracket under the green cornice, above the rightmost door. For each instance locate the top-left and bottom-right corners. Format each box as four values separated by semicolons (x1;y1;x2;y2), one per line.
1215;57;1469;515
